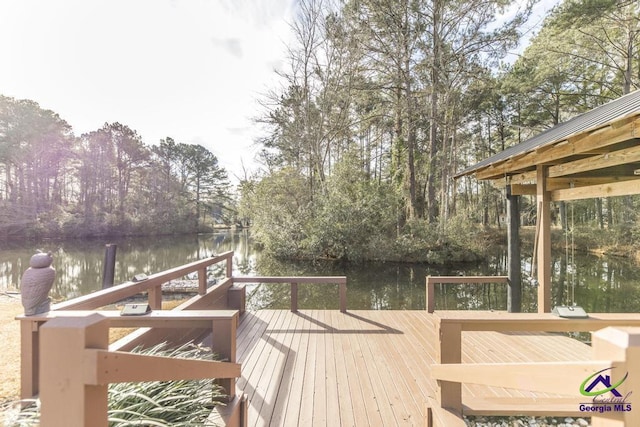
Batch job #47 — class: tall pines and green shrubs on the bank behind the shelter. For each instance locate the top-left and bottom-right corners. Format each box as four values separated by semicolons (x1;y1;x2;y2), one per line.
242;0;640;261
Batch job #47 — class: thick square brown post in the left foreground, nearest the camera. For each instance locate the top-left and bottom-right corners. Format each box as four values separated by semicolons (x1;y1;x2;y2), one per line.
40;314;109;427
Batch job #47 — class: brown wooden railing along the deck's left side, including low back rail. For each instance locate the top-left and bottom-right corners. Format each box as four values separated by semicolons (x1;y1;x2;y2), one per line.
17;252;347;426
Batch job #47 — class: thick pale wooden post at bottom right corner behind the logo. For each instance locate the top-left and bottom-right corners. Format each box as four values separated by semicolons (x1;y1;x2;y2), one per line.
591;327;640;427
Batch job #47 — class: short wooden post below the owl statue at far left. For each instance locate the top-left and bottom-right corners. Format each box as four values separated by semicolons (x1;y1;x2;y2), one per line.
20;318;42;399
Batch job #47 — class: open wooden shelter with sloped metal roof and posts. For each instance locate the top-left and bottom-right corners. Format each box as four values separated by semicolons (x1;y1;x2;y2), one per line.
456;91;640;313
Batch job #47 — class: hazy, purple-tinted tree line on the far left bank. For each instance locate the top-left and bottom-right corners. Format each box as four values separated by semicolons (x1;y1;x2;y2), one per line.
0;96;231;236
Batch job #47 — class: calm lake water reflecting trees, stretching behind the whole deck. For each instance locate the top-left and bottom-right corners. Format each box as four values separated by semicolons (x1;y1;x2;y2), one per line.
0;230;640;312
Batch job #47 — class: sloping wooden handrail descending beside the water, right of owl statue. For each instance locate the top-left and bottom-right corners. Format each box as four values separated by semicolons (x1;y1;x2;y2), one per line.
51;251;233;310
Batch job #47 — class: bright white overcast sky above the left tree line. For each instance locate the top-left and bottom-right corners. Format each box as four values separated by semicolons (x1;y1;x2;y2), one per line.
0;0;556;182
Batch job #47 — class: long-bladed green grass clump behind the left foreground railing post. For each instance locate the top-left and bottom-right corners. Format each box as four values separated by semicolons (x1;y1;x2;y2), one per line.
3;343;224;427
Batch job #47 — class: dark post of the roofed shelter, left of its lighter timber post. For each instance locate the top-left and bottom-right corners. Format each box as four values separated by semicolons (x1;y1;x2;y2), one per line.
507;185;522;313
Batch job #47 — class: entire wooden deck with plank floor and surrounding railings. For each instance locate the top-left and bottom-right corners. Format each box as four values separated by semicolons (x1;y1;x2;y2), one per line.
18;252;640;427
